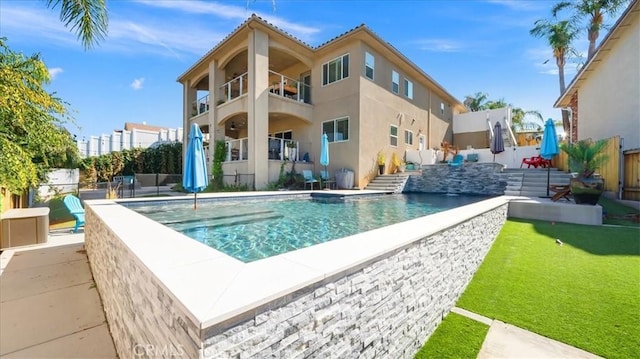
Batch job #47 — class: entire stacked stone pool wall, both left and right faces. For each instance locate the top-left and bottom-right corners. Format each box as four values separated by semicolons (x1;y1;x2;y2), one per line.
85;204;507;358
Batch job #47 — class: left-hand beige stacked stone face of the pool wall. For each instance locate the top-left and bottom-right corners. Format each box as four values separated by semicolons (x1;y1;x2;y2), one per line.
85;206;201;358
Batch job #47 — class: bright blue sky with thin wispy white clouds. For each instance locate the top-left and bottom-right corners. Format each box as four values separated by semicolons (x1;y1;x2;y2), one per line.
0;0;612;138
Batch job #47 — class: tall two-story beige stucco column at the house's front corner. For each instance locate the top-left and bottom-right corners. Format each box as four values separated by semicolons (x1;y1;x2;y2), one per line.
247;29;269;188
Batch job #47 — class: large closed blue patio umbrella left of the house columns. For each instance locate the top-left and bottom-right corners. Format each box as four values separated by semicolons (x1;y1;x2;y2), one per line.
182;123;209;209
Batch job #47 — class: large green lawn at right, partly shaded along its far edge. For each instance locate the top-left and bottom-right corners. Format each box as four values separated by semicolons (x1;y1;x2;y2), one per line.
457;219;640;358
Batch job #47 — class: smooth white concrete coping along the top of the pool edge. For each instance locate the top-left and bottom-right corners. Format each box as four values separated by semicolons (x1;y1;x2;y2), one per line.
85;191;510;335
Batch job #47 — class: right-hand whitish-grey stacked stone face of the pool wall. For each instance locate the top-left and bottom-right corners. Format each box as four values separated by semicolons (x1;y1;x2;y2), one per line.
203;204;508;358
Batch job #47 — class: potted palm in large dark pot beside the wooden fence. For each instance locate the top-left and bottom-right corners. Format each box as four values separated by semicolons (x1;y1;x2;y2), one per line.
560;139;609;205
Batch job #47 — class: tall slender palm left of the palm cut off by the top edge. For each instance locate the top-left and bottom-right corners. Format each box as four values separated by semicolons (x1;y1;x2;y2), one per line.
529;20;578;133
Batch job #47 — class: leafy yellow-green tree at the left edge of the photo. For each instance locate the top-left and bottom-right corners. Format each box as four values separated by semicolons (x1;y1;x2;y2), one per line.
0;38;75;192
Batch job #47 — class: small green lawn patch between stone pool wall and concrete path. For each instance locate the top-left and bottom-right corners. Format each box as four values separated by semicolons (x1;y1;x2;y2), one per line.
415;313;489;359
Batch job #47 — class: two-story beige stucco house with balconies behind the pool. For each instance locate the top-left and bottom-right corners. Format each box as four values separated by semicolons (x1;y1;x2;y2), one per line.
178;15;466;189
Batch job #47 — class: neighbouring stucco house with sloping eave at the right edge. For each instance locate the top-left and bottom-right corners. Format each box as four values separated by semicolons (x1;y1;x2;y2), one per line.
554;0;640;151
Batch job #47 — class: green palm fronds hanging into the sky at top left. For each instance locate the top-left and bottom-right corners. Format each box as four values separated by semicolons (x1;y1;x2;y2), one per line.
46;0;109;49
